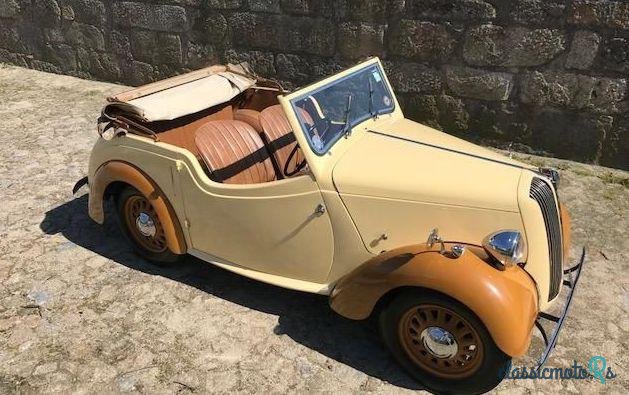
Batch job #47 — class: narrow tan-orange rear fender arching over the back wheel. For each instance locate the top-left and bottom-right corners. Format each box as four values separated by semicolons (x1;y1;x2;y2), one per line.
88;161;186;255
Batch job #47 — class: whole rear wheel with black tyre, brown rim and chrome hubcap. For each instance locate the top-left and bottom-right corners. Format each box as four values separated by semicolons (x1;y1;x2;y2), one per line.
116;187;181;264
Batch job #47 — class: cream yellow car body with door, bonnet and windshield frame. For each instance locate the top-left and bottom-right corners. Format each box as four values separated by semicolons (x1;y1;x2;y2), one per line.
88;59;568;364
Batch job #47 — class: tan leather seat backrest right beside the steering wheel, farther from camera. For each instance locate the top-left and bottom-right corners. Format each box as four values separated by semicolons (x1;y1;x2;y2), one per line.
260;104;304;176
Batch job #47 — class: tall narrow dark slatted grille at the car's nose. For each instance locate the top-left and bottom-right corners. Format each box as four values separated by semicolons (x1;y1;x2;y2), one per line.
529;177;563;300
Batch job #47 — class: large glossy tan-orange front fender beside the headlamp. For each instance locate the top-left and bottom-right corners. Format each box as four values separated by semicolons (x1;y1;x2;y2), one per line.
330;245;538;357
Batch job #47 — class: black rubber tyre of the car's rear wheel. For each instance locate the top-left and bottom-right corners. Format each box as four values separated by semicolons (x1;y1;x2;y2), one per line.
115;186;184;266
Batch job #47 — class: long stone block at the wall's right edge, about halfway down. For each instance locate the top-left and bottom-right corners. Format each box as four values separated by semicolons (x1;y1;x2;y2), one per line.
520;71;627;113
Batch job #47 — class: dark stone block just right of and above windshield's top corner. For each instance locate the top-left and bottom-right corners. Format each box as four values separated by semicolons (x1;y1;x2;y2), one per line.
389;19;455;61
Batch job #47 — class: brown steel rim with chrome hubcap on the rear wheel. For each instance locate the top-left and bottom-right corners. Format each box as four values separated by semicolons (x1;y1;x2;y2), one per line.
124;196;168;253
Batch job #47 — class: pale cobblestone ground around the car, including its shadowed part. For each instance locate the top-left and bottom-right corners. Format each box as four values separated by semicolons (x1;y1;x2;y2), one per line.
0;65;629;393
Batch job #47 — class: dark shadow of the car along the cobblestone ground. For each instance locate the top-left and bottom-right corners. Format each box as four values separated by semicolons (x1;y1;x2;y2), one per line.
40;195;423;390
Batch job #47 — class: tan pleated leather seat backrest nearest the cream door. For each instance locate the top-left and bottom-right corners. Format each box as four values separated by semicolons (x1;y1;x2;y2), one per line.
195;120;275;184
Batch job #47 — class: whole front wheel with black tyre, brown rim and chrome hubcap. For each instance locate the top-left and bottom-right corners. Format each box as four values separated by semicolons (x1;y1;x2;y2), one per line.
380;290;511;394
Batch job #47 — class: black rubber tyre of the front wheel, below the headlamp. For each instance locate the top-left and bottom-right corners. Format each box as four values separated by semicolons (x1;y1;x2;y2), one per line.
379;290;511;394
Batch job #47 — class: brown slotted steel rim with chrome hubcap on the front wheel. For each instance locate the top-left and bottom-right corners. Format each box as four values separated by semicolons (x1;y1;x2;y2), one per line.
398;305;484;379
